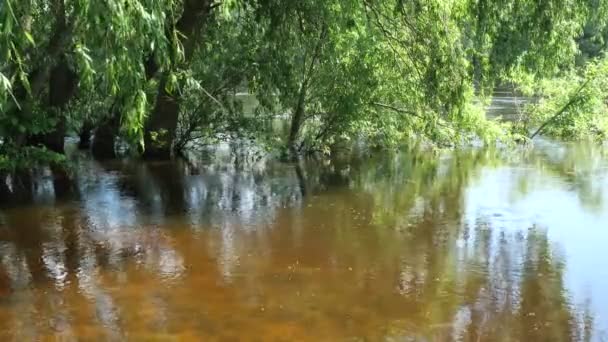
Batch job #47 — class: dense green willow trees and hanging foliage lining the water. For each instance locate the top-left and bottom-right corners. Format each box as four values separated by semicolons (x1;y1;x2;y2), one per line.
0;0;608;179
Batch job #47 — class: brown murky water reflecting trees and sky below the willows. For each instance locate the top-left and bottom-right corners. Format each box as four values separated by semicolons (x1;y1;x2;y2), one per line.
0;142;608;341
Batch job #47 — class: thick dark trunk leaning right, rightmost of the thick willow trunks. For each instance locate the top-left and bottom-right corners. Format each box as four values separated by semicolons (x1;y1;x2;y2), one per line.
143;0;213;159
